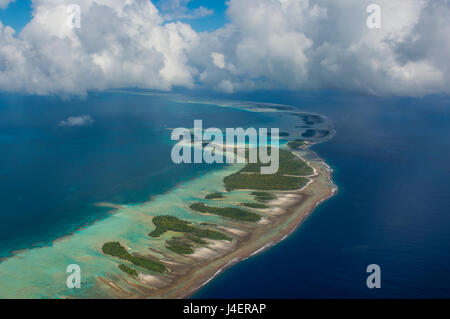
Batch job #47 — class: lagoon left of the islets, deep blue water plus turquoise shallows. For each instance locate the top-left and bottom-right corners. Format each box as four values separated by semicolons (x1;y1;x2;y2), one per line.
0;93;330;298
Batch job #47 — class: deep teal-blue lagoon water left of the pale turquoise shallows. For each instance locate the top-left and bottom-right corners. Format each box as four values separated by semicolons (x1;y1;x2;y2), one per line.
0;93;272;258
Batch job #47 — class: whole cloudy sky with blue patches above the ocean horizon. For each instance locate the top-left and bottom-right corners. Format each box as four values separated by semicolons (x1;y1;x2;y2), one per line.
0;0;450;97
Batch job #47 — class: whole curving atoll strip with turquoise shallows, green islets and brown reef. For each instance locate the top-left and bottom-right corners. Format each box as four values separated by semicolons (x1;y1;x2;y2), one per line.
2;96;336;298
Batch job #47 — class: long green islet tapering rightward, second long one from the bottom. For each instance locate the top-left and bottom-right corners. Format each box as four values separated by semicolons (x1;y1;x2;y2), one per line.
149;216;231;240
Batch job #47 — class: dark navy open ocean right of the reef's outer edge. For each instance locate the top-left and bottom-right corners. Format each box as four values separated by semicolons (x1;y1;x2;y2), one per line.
194;92;450;298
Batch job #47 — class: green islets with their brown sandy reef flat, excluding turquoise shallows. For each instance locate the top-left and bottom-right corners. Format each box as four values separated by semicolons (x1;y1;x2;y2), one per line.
98;140;335;298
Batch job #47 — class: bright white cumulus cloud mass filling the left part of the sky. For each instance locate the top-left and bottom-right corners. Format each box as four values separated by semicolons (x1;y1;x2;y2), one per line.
0;0;198;94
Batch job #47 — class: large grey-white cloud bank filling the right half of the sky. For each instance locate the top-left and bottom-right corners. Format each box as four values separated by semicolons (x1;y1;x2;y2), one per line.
195;0;450;96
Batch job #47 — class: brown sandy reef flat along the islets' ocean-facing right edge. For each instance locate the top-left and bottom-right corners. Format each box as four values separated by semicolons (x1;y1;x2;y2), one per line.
96;148;337;298
